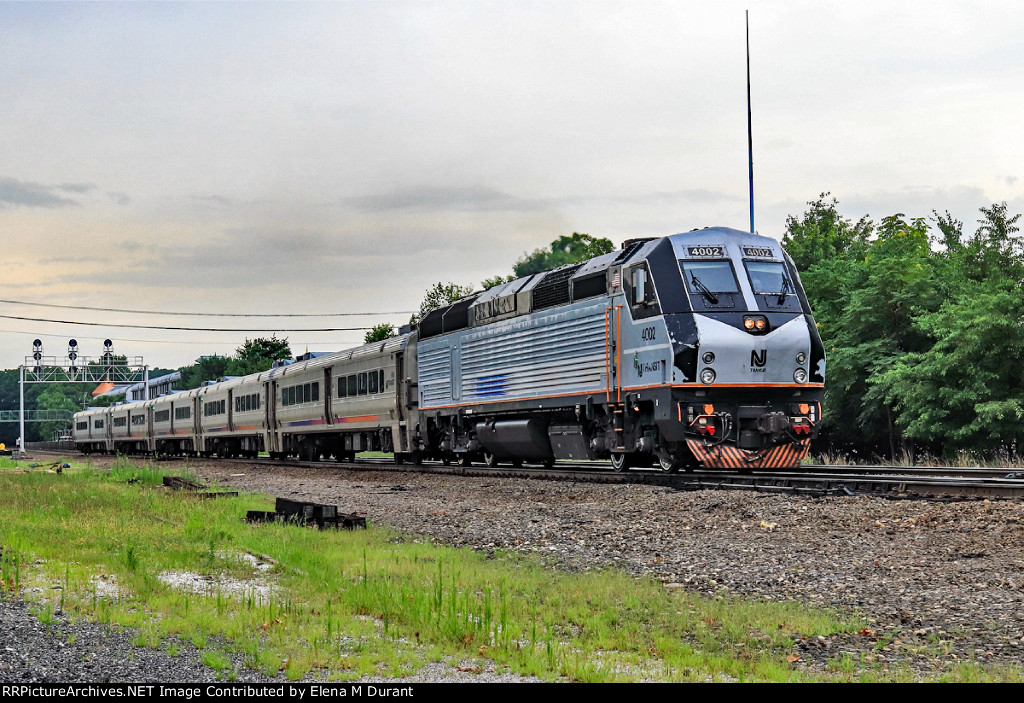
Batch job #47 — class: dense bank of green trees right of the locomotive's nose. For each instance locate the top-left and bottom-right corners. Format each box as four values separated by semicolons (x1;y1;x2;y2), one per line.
783;193;1024;456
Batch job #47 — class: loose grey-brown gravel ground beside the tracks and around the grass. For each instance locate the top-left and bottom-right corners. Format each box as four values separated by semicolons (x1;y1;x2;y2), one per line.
6;459;1024;682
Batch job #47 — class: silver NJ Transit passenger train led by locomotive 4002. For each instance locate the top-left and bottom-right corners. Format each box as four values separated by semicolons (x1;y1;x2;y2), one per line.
75;227;825;471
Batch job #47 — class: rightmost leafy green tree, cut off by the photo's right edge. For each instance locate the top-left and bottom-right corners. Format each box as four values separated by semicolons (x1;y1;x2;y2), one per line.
883;203;1024;455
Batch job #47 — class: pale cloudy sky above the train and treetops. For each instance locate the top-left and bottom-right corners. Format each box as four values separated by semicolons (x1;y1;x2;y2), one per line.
0;0;1024;367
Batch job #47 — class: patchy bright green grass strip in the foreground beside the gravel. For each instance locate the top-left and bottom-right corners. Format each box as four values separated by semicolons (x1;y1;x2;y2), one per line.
0;460;1018;682
